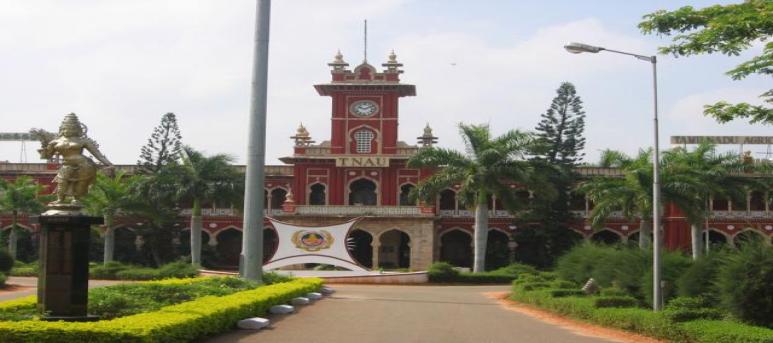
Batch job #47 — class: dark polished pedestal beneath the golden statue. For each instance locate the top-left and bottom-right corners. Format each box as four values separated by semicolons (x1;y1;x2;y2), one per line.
38;214;103;321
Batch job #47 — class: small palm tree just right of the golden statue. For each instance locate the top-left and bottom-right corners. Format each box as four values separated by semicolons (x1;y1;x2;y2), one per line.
84;172;136;263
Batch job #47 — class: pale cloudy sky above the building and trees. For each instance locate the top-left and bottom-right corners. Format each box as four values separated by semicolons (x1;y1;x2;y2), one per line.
0;0;771;164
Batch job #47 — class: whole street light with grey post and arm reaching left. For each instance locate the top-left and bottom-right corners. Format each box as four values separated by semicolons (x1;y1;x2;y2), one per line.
564;43;663;311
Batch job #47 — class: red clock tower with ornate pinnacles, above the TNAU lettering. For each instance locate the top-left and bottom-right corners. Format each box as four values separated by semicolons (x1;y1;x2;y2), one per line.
314;51;416;155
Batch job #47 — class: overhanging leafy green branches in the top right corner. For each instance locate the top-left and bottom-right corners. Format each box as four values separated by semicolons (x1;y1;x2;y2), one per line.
639;0;773;125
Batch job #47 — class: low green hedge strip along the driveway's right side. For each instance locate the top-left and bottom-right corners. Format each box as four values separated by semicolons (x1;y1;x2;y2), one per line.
510;282;773;343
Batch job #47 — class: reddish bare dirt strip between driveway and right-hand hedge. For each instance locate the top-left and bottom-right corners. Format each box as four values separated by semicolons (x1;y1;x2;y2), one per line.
483;292;664;343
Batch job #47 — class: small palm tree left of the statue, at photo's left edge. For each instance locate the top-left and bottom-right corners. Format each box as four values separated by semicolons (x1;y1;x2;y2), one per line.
0;176;45;258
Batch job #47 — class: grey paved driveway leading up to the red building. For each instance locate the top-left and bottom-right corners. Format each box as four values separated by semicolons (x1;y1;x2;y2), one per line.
209;285;611;343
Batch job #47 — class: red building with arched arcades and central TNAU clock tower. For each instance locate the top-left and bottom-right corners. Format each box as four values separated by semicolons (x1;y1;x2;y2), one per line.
0;52;773;270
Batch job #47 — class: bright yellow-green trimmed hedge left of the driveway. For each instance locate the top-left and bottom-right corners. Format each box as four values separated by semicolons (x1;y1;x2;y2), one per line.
0;278;322;342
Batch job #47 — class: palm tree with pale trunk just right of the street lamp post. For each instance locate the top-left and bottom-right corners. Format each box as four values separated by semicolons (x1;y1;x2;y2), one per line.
663;143;757;259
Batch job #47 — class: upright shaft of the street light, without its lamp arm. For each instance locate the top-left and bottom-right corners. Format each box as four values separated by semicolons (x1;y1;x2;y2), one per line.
650;56;663;311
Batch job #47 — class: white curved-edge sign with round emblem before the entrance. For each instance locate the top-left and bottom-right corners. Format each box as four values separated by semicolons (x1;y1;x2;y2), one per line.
263;218;367;271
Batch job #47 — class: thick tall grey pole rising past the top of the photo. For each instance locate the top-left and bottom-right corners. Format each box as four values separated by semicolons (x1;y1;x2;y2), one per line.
239;0;271;282
